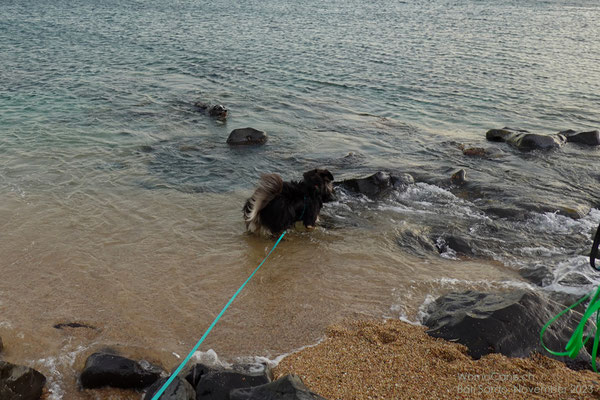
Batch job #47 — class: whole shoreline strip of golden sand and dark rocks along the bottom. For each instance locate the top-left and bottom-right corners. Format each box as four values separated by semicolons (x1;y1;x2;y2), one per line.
0;290;600;400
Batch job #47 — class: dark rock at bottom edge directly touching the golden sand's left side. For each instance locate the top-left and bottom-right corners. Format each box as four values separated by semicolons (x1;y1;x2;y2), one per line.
229;375;325;400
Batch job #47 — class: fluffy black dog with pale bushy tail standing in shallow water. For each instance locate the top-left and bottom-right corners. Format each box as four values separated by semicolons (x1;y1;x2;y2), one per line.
243;169;334;235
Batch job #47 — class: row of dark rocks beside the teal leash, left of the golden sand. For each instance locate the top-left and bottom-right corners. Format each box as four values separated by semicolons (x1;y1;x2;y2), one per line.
79;353;324;400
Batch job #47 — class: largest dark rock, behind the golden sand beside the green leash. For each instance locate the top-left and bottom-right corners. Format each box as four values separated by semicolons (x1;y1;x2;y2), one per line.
425;291;590;361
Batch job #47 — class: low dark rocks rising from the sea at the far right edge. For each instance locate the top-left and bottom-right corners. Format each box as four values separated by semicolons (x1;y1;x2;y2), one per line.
486;127;600;150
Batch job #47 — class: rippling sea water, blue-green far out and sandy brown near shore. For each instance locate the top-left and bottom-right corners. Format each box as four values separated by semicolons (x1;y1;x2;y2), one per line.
0;0;600;400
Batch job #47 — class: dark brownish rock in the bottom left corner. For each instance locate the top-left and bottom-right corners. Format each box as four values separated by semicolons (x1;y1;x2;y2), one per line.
0;361;46;400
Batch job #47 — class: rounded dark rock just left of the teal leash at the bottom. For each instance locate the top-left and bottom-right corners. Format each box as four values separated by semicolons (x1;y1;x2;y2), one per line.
79;353;161;389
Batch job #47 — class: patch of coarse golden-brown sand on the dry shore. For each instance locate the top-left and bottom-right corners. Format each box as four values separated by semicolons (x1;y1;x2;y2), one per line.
275;320;600;400
